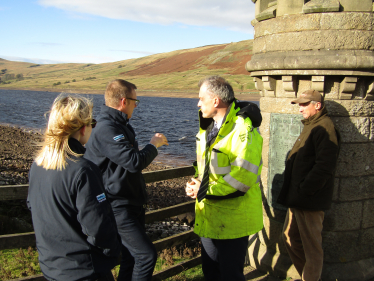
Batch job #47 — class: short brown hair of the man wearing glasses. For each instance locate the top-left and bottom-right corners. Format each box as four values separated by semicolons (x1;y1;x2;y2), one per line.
104;79;137;107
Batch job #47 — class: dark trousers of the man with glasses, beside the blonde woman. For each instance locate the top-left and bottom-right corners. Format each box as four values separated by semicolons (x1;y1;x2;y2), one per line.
113;205;157;281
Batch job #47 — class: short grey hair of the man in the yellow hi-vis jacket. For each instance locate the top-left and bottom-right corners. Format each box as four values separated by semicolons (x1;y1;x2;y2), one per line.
199;75;235;104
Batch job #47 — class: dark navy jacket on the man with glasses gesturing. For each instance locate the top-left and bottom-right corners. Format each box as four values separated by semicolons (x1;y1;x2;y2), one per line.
84;105;158;208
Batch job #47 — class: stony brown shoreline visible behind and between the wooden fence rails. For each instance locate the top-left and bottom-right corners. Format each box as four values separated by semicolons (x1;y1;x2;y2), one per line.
0;125;191;235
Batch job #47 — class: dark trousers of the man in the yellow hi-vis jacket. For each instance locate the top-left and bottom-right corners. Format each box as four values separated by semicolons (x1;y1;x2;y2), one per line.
201;236;248;281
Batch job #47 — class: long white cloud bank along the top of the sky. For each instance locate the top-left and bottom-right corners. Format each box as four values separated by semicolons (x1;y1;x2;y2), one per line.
38;0;255;33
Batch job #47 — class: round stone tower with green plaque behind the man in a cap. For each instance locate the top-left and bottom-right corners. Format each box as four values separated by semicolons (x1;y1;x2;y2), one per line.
246;0;374;281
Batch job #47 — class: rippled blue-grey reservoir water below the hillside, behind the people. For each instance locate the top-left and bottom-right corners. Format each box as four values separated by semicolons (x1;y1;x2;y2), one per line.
0;90;258;166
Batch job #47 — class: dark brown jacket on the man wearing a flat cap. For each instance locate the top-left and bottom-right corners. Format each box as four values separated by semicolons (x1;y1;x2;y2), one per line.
277;107;340;210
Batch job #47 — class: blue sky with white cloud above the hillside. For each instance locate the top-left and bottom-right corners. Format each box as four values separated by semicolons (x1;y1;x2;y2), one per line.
0;0;255;64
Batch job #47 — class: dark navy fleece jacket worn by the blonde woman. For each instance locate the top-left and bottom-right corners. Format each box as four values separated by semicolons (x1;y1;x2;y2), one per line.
27;138;121;281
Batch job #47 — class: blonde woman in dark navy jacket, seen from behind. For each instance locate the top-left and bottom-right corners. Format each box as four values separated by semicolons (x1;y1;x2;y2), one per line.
27;94;121;281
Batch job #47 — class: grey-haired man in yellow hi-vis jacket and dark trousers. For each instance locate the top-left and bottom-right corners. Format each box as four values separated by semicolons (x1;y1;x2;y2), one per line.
186;76;263;281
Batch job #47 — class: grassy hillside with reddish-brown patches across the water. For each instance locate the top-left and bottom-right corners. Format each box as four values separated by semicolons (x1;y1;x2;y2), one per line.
0;40;254;96
